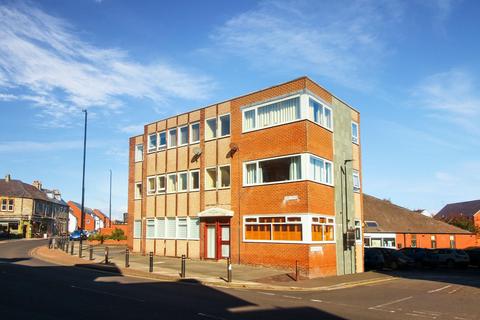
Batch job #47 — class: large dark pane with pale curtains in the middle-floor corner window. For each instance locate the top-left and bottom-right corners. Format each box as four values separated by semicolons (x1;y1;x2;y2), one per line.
258;156;301;183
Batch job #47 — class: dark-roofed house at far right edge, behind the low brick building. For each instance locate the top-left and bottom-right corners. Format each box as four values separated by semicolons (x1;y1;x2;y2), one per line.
435;200;480;236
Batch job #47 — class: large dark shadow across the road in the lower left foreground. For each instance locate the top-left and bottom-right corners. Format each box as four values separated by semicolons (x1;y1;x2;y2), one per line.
0;258;342;320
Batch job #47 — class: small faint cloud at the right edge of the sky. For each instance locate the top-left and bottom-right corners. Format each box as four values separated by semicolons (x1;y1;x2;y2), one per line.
413;69;480;134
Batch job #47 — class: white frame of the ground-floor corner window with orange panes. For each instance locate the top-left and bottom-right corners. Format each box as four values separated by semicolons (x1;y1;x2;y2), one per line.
242;213;337;244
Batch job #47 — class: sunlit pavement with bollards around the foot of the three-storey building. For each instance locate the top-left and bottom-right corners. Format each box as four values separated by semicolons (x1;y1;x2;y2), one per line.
33;243;395;291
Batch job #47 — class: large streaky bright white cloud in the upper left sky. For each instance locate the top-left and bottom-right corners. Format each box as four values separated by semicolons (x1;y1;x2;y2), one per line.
0;4;214;126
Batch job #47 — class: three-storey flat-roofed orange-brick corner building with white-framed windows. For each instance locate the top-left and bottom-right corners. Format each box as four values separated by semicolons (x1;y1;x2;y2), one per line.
128;77;363;277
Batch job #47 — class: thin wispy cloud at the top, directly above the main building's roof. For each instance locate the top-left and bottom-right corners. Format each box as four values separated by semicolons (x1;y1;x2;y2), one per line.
212;1;403;88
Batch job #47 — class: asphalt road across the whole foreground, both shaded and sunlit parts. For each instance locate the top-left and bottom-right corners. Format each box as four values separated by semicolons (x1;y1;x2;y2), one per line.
0;241;480;320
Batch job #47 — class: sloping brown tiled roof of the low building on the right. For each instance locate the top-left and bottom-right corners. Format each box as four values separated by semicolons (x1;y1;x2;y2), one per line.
363;194;470;234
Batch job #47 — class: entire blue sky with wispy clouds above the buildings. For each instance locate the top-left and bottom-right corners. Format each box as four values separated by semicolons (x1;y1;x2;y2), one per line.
0;0;480;217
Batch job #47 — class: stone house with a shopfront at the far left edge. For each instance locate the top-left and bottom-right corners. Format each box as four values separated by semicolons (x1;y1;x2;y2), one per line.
0;174;68;238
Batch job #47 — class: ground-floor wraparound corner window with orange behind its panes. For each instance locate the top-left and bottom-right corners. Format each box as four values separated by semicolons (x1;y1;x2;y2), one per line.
244;214;335;243
